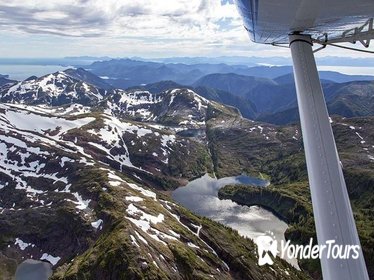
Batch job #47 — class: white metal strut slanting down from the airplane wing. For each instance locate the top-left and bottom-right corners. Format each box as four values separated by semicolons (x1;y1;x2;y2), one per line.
289;35;369;280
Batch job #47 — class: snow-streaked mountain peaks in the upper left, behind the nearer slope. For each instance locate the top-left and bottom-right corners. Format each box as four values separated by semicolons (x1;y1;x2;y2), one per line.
0;69;209;128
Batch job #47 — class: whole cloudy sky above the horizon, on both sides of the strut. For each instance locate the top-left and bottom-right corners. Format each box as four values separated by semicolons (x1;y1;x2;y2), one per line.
0;0;368;57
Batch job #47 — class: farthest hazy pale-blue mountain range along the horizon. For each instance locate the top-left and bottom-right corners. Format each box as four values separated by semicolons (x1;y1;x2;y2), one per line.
84;59;374;89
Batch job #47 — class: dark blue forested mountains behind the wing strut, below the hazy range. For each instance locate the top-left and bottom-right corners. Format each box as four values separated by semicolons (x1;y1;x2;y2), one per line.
194;72;374;124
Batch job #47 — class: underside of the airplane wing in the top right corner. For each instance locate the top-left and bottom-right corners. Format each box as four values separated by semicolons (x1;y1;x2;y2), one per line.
235;0;374;44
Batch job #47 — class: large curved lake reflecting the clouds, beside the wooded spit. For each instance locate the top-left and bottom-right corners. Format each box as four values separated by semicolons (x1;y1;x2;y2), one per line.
172;174;298;268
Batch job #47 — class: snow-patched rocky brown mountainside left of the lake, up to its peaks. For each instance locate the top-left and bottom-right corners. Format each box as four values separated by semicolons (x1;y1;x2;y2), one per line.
0;72;308;279
